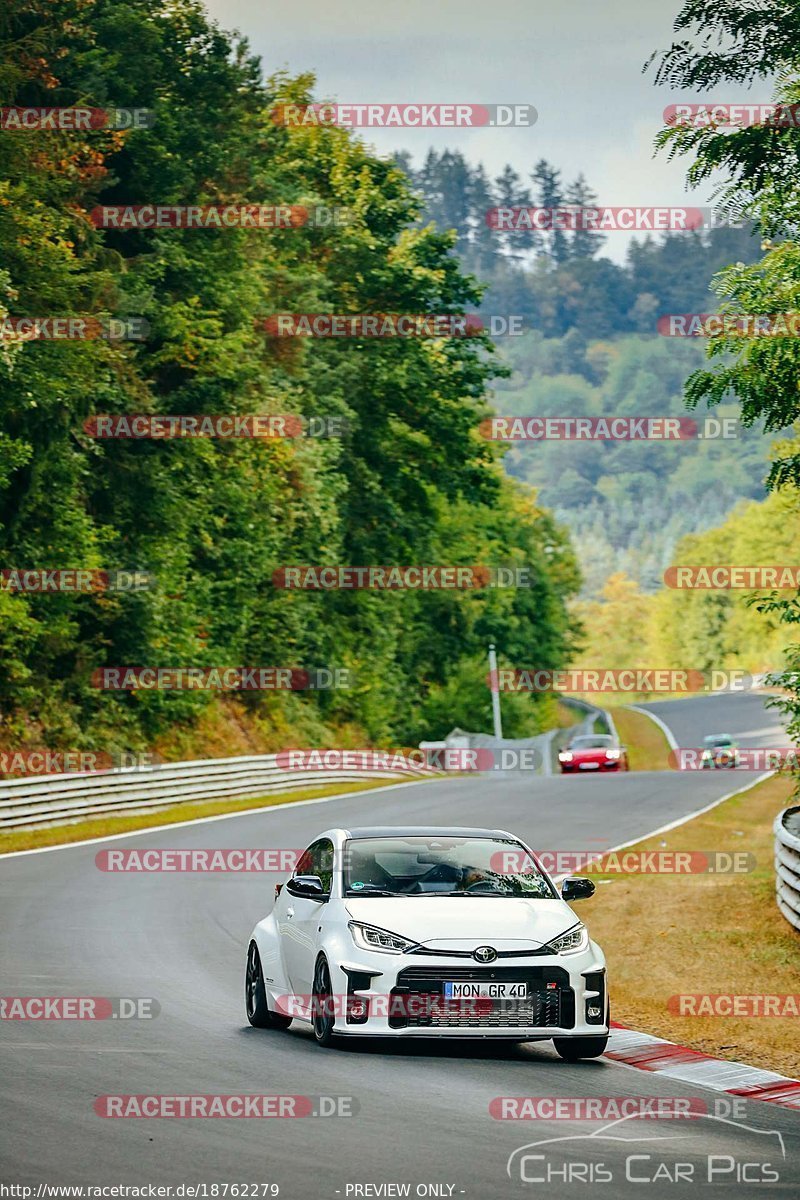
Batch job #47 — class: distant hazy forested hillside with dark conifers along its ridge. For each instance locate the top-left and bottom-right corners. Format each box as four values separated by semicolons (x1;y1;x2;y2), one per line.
398;150;769;598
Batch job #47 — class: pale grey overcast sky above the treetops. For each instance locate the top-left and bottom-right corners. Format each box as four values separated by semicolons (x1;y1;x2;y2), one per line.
201;0;770;258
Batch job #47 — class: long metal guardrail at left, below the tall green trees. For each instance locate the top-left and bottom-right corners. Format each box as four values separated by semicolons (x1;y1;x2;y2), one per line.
0;754;438;830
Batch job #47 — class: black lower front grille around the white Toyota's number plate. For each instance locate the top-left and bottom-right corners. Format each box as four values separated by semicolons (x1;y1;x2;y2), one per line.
389;967;575;1030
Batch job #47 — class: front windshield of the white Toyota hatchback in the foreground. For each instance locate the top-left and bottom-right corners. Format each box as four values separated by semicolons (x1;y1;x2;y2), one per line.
344;836;558;899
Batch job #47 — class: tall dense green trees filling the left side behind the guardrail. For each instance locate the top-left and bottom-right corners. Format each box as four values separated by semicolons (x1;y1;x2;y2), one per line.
0;0;579;756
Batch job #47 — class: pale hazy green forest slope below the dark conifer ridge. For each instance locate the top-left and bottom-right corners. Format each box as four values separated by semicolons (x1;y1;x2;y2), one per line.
494;334;770;596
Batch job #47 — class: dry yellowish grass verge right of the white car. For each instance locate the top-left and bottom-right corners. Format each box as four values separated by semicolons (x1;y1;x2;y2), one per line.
581;776;800;1078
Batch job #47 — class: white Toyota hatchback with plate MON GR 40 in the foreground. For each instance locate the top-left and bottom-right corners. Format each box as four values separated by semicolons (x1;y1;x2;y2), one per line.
245;828;609;1061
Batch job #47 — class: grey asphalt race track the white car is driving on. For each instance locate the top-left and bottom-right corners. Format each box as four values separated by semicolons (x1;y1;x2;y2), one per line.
0;695;800;1200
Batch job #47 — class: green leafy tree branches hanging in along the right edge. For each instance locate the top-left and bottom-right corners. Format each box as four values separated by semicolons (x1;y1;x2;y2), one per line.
656;0;800;734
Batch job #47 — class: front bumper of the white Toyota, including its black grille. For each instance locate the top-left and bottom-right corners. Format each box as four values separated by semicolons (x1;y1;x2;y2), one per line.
331;942;608;1042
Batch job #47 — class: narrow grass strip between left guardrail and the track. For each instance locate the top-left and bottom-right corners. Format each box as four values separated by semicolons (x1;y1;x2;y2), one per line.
0;779;407;856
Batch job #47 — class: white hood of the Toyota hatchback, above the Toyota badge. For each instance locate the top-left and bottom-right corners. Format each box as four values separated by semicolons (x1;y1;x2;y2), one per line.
344;895;579;949
